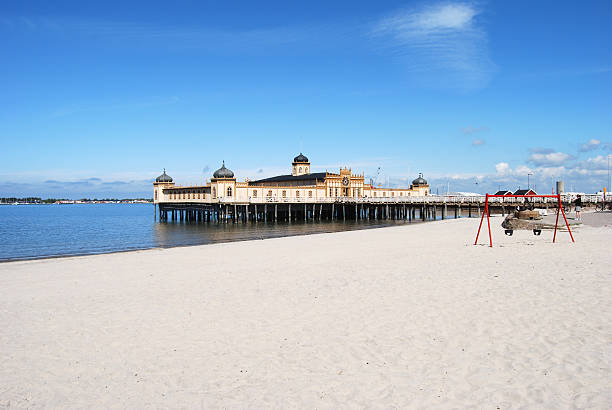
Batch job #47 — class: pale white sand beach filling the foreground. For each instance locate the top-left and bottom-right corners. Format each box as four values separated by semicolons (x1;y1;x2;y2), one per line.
0;218;612;409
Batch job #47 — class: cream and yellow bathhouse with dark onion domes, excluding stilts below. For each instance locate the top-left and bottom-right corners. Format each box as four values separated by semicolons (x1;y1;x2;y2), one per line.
153;153;429;203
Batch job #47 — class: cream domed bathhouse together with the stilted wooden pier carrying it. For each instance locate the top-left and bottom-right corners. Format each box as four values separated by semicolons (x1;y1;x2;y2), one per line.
153;153;592;222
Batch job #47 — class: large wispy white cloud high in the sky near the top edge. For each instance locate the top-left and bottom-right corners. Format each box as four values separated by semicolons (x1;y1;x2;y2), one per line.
373;2;494;89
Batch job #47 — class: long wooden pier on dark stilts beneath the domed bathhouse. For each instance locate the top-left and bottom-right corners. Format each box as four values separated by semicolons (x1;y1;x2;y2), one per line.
156;195;597;223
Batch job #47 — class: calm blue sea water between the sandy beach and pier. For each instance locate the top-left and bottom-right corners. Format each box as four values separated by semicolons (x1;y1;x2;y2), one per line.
0;204;432;261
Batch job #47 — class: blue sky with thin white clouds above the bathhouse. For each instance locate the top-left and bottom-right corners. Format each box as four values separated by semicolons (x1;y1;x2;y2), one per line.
0;1;612;198
